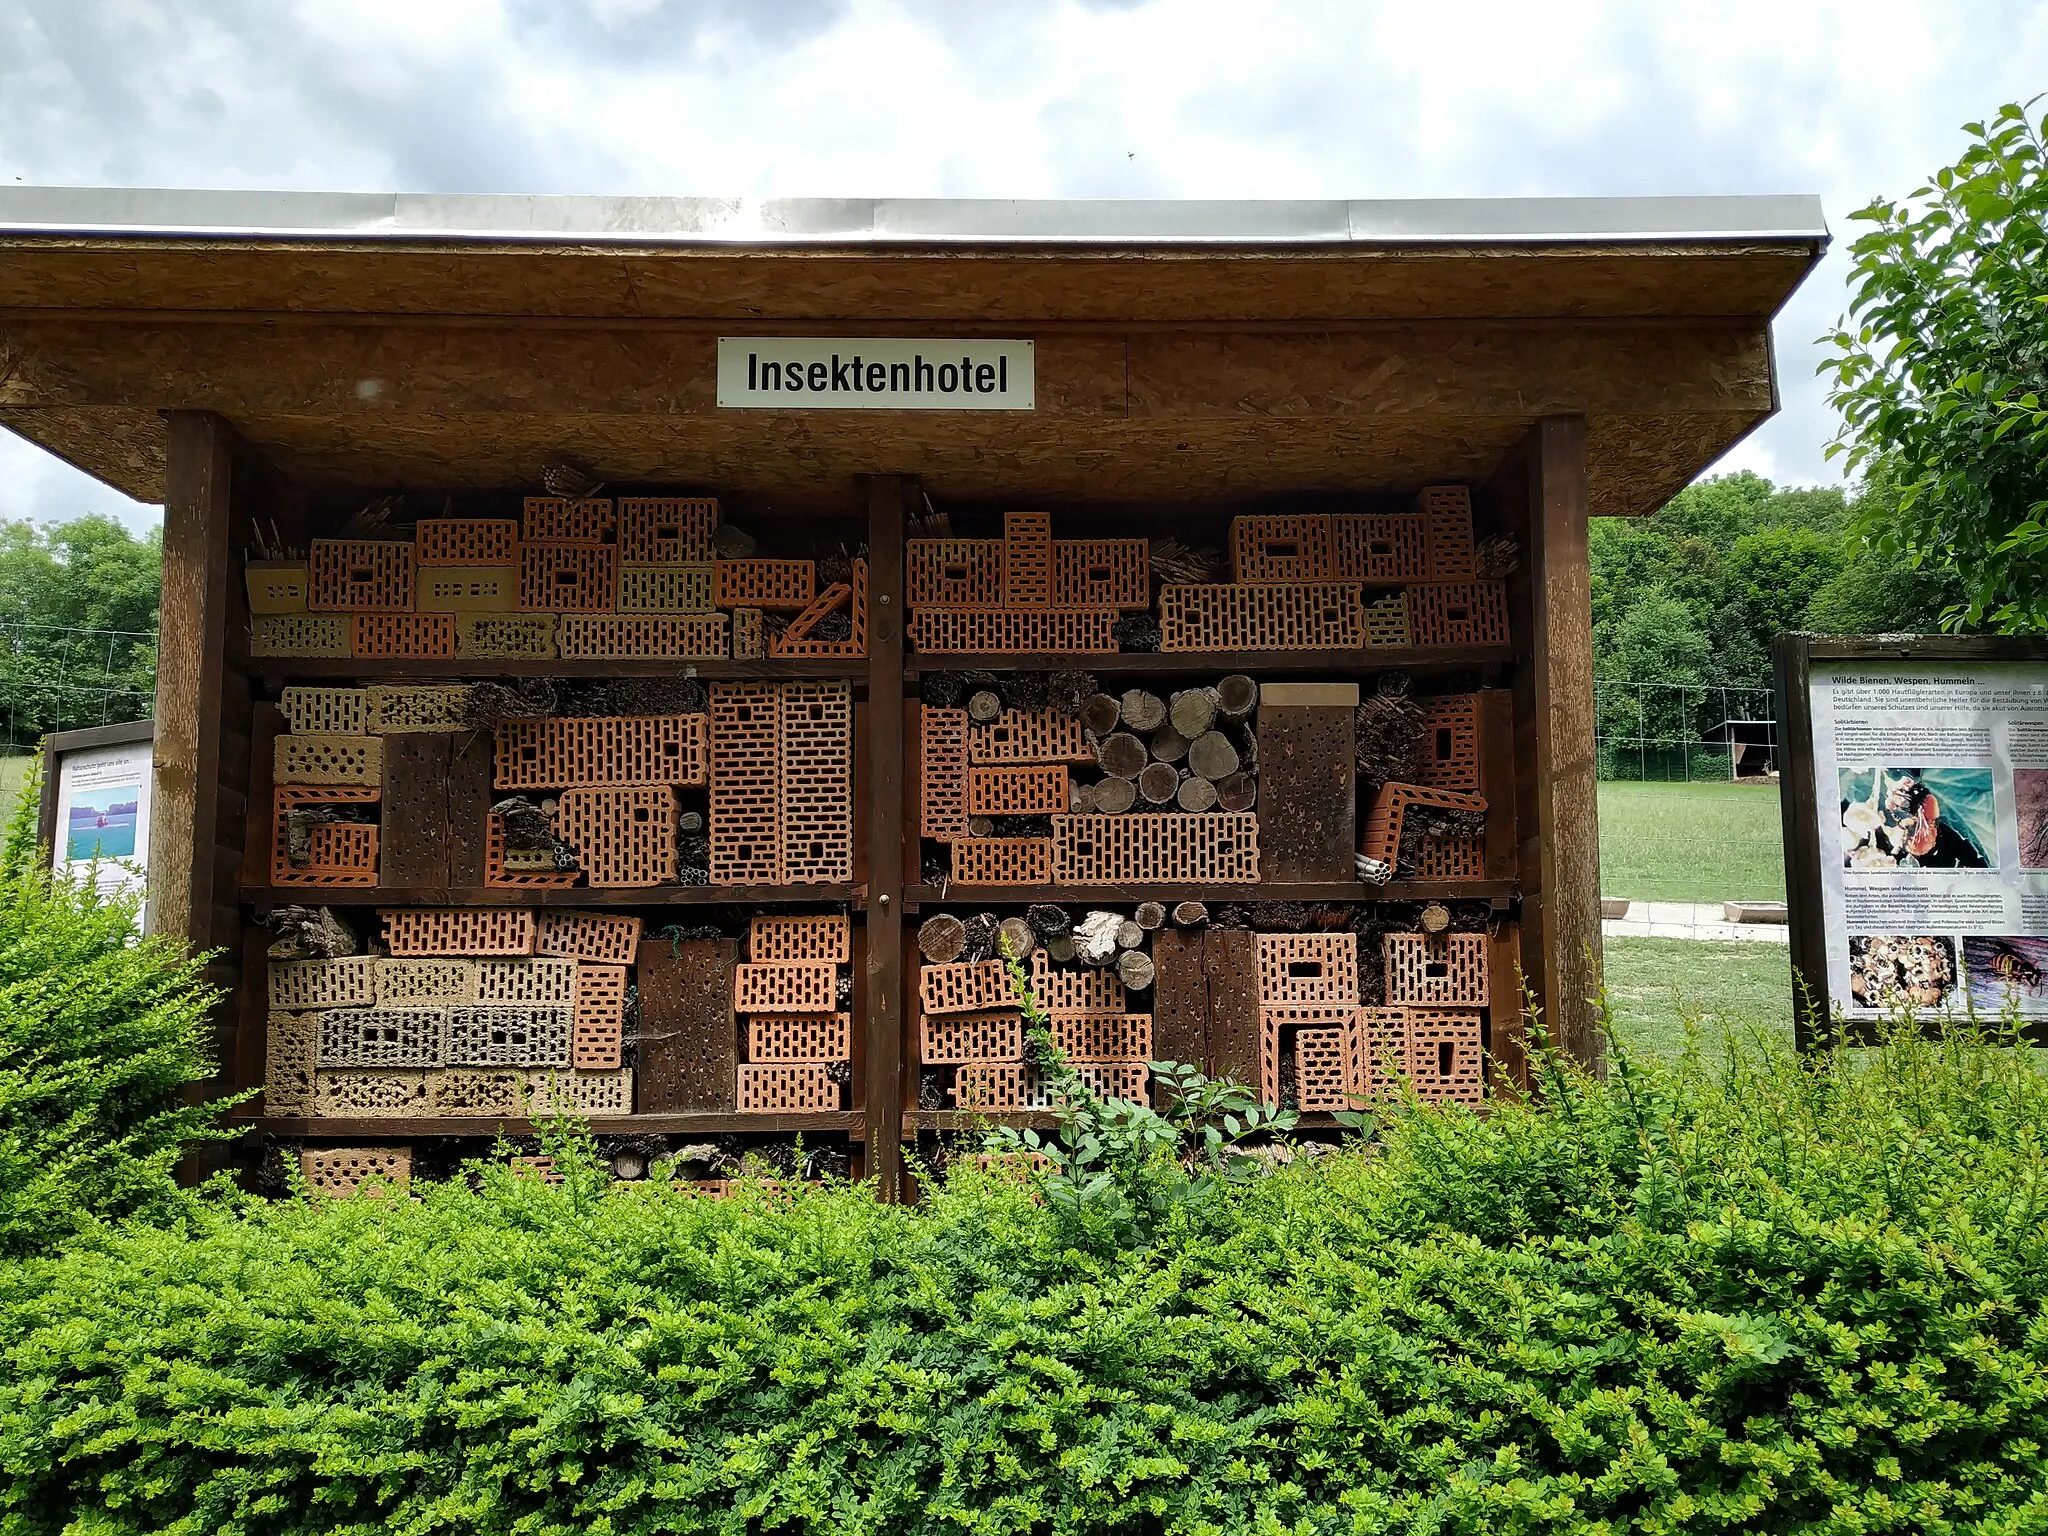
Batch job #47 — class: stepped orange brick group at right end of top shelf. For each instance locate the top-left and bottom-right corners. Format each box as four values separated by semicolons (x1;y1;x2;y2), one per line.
1159;485;1507;651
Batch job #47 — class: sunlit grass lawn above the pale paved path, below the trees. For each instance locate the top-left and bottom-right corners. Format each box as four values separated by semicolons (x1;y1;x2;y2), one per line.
1599;784;1786;901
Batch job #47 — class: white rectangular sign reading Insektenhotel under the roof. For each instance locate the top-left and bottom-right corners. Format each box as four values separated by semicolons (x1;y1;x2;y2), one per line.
719;336;1034;412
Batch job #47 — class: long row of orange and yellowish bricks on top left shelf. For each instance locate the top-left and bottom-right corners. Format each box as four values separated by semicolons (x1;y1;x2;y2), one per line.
248;496;866;659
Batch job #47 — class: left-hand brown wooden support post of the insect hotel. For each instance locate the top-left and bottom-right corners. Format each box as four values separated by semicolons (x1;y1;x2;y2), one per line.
143;412;233;950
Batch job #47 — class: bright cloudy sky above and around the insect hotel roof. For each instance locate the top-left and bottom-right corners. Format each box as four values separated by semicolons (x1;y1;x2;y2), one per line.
0;0;2048;524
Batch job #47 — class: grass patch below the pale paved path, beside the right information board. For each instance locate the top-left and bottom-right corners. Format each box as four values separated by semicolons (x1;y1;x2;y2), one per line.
1604;938;1792;1057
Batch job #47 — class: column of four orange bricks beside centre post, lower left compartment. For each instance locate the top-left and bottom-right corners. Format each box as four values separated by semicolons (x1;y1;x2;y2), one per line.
733;915;852;1114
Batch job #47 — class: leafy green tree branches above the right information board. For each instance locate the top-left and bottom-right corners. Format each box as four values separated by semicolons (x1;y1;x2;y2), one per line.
1821;102;2048;633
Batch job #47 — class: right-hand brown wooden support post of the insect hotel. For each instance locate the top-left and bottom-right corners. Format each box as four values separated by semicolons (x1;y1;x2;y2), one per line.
1489;416;1606;1071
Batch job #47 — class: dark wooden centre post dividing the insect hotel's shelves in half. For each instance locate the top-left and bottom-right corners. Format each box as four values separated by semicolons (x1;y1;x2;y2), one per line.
866;475;911;1200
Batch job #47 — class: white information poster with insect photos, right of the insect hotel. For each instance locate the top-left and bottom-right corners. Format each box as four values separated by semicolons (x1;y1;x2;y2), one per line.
1810;662;2048;1020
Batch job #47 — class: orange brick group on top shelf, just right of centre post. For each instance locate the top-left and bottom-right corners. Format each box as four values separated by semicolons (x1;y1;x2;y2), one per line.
905;512;1151;655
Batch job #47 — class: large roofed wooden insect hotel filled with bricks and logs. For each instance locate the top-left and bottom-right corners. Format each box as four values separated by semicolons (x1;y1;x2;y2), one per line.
0;188;1825;1198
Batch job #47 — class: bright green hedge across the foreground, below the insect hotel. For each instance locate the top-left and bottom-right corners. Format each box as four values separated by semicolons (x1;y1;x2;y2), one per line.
0;1024;2048;1536
